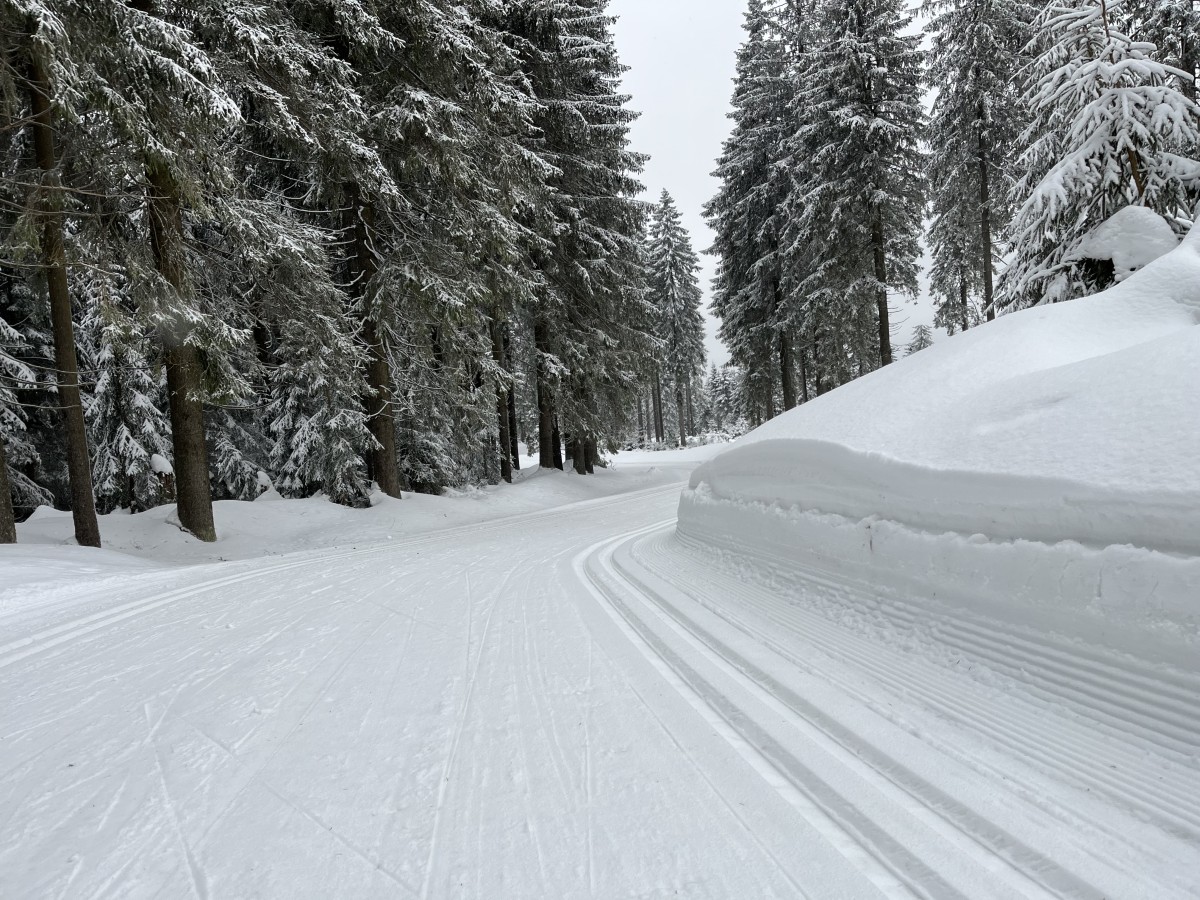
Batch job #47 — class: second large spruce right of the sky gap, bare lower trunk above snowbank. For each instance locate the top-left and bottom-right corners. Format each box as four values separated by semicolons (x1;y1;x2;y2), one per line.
788;0;925;374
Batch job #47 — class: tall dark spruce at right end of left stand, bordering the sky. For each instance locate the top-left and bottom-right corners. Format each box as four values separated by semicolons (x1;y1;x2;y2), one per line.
506;0;653;469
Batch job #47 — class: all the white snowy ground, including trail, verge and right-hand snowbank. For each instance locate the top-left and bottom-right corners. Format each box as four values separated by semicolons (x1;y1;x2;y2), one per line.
0;238;1200;900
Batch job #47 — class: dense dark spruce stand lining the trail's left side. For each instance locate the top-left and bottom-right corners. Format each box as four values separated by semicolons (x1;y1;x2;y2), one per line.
0;0;667;545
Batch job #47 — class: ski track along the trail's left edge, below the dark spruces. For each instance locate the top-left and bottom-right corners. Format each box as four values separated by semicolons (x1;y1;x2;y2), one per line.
0;484;679;670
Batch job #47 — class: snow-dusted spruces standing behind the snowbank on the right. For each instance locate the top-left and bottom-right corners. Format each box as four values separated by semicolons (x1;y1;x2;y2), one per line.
707;0;1200;421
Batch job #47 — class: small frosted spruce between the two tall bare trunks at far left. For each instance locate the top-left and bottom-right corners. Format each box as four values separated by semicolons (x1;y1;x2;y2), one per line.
73;269;170;512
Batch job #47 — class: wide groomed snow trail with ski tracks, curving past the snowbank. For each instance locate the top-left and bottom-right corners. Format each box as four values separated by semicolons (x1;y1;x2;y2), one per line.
0;475;1200;900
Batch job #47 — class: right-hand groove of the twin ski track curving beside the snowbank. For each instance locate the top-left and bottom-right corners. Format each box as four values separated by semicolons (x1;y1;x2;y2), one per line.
584;529;1142;896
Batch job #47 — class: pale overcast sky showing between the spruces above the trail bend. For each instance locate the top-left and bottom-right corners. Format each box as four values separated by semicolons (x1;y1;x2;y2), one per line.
608;0;934;365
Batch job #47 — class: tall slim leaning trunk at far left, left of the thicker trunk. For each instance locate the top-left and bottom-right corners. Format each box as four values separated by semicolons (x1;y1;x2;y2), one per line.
29;40;100;547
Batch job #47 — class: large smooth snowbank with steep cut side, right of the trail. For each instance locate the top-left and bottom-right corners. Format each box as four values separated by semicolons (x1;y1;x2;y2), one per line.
679;218;1200;638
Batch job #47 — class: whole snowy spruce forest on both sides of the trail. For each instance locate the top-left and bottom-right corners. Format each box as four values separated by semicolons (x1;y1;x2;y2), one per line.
0;0;1200;546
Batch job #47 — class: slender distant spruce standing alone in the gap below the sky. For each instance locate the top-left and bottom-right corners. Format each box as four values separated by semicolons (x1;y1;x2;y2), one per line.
647;191;704;446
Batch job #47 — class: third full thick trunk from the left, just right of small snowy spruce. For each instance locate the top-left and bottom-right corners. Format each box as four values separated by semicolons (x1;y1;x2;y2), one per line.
349;192;402;499
